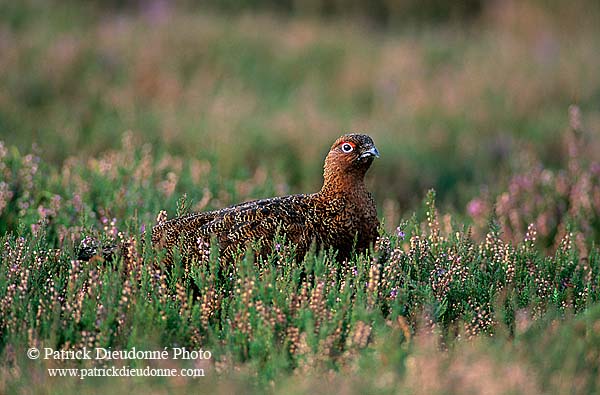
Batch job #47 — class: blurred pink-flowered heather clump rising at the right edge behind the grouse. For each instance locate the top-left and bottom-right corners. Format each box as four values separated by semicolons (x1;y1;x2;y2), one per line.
467;106;600;252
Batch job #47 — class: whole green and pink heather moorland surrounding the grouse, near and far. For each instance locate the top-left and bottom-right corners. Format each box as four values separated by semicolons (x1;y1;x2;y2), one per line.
0;1;600;394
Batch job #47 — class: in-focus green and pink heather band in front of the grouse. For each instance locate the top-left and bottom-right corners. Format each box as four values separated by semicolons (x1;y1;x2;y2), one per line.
0;180;600;393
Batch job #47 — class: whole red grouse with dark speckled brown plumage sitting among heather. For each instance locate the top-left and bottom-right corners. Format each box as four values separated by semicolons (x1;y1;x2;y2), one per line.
152;134;379;262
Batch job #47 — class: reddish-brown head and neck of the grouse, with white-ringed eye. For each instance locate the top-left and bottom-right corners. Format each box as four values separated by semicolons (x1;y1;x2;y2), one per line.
323;133;379;192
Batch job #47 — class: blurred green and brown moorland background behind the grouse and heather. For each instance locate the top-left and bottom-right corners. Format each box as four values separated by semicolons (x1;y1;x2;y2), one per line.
0;0;600;220
